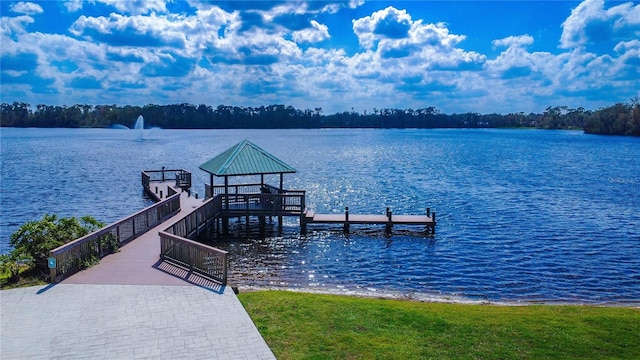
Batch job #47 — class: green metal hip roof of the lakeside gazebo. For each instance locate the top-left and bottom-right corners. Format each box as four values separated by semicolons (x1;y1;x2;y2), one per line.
200;140;296;176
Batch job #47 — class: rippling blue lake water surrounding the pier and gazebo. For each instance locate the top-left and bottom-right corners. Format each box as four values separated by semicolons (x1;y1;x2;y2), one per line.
0;128;640;304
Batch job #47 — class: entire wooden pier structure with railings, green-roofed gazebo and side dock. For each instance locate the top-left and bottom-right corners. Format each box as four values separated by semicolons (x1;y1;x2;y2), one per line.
49;140;436;286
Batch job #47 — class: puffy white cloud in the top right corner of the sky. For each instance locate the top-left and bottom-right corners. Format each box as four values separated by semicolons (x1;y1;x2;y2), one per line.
560;0;640;49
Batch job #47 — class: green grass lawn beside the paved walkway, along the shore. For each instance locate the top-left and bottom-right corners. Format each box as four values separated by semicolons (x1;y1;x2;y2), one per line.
238;291;640;360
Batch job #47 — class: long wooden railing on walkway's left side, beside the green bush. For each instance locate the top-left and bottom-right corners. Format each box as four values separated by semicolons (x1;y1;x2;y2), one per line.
49;191;180;282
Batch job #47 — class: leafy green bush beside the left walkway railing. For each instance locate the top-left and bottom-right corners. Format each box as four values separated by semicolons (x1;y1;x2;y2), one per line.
9;214;104;274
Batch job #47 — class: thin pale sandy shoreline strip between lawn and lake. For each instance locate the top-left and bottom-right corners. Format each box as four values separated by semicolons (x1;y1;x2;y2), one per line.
234;283;640;309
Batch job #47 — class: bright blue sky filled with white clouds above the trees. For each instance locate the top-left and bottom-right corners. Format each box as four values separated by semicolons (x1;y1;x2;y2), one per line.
0;0;640;114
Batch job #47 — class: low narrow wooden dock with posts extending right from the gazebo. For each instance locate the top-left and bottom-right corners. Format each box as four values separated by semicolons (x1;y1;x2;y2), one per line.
300;207;436;233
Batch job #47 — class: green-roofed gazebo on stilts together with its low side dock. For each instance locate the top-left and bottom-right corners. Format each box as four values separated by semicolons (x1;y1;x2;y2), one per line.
196;140;436;234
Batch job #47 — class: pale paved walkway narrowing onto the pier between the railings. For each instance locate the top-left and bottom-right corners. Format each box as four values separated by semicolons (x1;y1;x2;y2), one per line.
0;187;275;360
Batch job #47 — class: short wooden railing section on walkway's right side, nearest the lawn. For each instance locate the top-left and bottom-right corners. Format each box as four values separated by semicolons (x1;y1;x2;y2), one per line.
160;231;228;285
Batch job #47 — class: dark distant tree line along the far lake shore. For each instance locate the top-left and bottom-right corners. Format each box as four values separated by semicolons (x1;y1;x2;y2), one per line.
1;98;640;136
